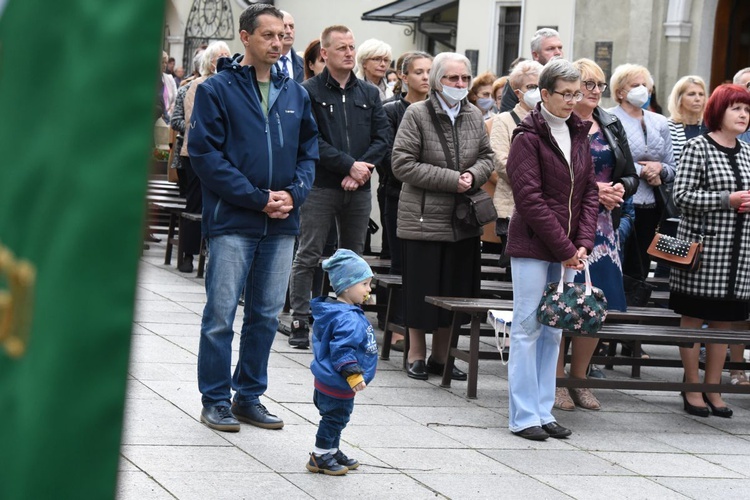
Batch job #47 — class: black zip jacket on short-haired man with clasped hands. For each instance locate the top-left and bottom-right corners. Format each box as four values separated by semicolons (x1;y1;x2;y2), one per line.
302;68;388;189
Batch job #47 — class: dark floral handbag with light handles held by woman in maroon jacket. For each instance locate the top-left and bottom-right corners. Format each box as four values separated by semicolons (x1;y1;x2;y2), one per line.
536;261;607;334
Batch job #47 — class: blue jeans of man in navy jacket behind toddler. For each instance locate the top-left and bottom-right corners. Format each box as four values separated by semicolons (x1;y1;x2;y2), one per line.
198;234;294;407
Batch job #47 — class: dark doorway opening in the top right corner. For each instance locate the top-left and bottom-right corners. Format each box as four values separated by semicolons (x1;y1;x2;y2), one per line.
711;0;750;89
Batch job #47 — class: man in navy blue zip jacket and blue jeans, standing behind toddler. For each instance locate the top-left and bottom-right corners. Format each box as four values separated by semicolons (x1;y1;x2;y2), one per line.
188;4;318;432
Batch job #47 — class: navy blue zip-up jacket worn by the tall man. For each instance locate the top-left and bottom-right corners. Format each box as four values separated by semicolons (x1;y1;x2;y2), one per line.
188;54;318;238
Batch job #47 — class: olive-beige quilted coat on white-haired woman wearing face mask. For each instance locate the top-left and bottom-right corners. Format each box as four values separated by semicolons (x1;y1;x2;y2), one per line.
391;92;493;242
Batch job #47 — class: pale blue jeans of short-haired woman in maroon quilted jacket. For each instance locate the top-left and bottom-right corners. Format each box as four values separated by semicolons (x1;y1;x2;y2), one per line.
508;257;575;432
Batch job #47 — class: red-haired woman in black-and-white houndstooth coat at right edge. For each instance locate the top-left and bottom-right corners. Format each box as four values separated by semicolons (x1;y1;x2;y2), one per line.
669;85;750;418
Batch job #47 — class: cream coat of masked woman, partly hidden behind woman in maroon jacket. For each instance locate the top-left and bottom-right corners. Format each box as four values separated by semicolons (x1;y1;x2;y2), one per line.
490;104;529;219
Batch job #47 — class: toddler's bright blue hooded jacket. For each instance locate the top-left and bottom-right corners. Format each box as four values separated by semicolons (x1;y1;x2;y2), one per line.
310;297;378;399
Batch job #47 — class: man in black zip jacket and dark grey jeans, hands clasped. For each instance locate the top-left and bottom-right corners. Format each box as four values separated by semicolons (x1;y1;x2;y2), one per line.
289;26;388;349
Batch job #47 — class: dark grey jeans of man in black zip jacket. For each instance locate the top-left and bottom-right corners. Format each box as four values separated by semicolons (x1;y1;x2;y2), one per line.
289;187;372;322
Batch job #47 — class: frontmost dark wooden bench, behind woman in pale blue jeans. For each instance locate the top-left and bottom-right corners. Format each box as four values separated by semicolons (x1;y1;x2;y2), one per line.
425;297;750;398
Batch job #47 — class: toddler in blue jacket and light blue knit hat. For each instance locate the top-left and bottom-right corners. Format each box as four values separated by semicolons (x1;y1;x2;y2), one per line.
307;249;378;476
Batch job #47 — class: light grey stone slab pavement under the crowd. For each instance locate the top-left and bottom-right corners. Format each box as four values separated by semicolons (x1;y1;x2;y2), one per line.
117;244;750;500
